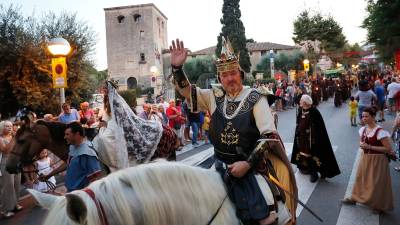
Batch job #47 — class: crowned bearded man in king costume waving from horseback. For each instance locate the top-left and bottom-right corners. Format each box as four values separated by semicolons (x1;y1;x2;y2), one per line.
170;38;297;225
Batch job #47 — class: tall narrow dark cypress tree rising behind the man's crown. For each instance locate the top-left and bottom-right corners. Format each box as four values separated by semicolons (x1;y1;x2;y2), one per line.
215;0;251;73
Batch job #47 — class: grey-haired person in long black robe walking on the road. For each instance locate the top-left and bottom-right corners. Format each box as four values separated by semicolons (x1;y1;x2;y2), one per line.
291;95;340;182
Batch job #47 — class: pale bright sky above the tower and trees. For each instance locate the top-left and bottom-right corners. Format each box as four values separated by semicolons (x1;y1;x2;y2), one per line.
0;0;367;70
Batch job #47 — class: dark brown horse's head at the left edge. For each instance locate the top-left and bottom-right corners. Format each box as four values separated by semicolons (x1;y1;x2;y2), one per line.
6;123;51;173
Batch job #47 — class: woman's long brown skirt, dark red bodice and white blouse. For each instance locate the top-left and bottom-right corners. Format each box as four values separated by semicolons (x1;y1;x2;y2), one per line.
351;126;393;211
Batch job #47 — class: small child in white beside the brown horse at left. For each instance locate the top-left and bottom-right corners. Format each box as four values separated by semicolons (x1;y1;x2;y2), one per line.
33;149;56;192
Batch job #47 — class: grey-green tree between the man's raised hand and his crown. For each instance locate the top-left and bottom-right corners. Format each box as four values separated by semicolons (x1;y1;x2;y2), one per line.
183;56;217;83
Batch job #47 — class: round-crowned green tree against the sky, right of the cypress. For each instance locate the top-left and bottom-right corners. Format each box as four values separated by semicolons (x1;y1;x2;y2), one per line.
292;10;346;52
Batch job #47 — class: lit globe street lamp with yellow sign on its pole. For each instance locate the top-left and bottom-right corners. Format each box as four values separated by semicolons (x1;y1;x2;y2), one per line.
47;37;71;106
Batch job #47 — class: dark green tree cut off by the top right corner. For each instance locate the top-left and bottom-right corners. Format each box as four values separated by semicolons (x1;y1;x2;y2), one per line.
362;0;400;62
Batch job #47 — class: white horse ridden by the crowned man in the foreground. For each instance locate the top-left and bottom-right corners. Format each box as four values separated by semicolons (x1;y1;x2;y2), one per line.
29;162;287;225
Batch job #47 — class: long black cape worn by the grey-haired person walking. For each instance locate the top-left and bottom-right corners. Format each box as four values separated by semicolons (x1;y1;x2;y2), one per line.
291;107;340;178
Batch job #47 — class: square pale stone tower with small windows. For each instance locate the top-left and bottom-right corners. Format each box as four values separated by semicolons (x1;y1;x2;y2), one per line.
104;4;168;92
